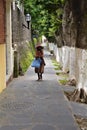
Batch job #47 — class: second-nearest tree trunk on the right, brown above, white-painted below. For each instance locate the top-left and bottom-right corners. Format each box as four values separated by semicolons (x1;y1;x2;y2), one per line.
62;1;71;73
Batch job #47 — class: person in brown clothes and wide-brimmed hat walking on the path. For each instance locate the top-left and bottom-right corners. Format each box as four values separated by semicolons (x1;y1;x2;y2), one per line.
35;45;45;81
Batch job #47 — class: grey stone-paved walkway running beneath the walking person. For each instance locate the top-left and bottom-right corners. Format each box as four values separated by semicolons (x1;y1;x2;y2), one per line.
0;52;79;130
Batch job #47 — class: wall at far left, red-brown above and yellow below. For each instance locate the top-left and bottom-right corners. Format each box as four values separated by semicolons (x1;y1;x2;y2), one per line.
0;0;6;92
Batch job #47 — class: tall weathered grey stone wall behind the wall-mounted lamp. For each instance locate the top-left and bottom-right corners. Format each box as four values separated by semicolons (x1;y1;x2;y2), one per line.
12;4;31;77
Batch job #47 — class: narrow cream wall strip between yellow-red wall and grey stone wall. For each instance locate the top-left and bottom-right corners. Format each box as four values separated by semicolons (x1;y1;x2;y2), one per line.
6;0;14;82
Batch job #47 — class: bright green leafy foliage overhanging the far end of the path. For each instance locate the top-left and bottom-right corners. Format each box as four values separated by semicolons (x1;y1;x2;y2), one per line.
24;0;65;41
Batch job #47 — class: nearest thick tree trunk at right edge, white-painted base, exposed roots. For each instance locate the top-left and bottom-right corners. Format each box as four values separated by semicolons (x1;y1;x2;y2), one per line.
69;0;87;102
